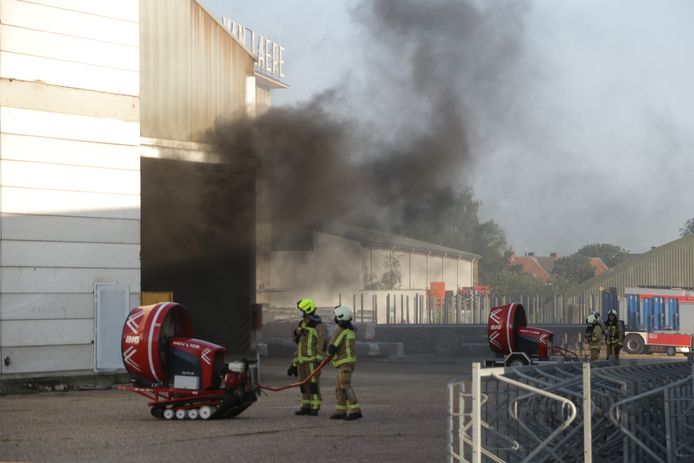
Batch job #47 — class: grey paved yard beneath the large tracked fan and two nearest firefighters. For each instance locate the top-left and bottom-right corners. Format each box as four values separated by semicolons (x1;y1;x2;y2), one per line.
0;358;490;463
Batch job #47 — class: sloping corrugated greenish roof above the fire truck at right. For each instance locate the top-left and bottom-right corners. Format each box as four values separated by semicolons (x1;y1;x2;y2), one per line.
566;236;694;308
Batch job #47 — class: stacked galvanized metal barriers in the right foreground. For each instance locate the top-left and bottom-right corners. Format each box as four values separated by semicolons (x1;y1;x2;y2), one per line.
448;361;694;463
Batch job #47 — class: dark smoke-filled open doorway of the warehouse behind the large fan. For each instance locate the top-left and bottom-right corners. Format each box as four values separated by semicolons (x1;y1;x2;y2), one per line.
141;158;255;353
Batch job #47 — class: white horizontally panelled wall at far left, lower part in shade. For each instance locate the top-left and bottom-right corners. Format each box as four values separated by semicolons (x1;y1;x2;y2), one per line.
0;0;140;376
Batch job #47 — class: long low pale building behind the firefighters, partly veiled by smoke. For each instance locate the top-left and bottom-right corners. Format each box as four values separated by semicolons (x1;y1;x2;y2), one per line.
270;224;479;322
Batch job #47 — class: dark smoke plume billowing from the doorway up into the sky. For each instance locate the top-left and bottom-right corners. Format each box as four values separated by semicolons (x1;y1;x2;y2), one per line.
210;0;522;245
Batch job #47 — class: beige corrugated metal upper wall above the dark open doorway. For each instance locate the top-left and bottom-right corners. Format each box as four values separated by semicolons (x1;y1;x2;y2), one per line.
140;0;254;141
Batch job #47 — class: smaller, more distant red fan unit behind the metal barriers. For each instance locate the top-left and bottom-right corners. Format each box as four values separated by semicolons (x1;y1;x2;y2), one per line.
487;303;564;366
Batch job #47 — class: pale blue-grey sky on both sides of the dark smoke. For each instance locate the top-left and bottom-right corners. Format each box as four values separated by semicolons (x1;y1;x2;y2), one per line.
202;0;694;255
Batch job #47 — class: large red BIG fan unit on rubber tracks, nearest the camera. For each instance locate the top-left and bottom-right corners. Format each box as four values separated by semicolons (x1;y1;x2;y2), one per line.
119;302;259;419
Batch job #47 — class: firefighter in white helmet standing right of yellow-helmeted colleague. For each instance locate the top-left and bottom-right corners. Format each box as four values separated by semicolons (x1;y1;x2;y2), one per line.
328;305;362;421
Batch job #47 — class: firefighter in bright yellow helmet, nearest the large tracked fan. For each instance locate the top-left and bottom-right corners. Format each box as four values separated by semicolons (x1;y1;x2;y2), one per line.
287;299;325;416
